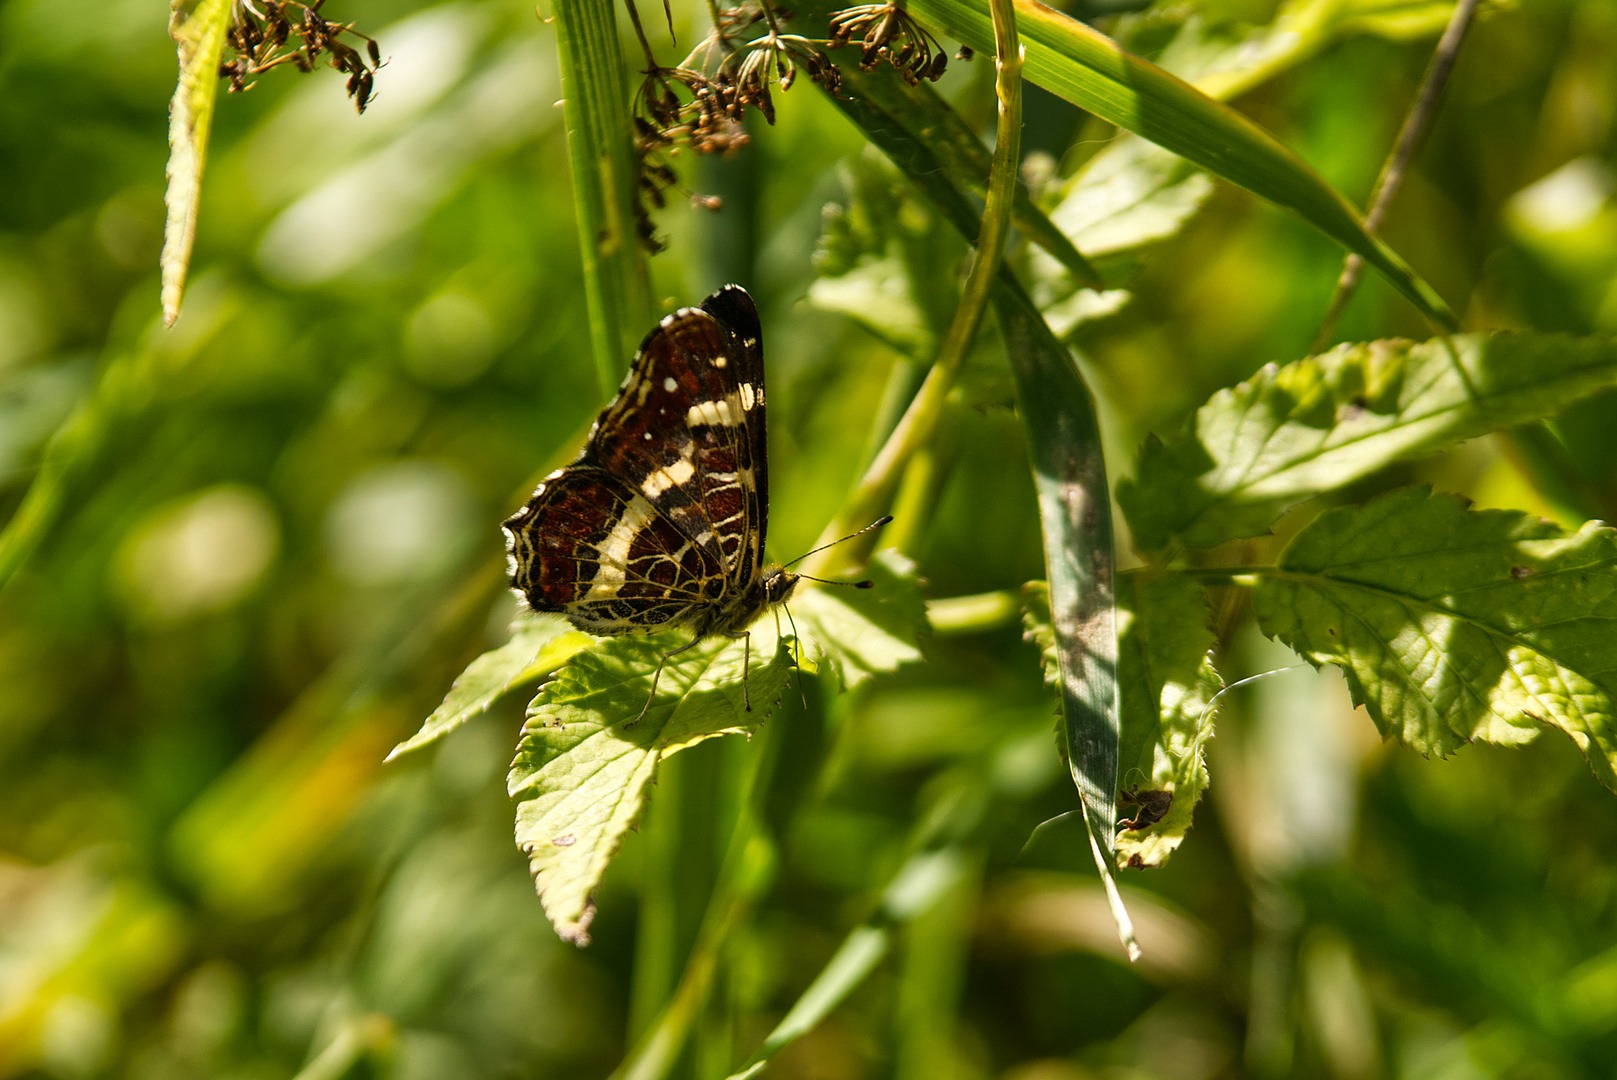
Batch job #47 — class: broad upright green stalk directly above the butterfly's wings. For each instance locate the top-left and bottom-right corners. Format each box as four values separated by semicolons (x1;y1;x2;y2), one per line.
555;0;652;398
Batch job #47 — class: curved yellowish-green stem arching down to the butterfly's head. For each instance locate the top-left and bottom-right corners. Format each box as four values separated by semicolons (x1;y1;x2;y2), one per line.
804;0;1022;577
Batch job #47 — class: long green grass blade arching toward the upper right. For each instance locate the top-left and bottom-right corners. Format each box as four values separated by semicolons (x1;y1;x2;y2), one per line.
909;0;1457;328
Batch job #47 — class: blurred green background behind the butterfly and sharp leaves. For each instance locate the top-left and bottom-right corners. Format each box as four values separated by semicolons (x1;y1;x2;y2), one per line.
0;0;1617;1080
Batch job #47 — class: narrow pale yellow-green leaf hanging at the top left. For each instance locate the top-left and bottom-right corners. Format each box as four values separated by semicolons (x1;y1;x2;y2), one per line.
158;0;231;327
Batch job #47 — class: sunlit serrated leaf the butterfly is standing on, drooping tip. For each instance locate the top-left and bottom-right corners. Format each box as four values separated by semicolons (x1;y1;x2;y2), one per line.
506;619;792;946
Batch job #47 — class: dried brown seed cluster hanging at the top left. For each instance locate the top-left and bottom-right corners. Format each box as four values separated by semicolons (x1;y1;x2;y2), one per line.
218;0;383;112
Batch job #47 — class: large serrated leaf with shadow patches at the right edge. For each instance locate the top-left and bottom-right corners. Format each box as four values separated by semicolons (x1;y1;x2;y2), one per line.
1252;488;1617;791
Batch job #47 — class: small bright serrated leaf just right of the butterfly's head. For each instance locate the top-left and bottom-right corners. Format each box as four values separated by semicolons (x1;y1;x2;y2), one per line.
791;550;927;687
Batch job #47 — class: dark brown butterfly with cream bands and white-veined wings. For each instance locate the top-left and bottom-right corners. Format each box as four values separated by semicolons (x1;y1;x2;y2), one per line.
503;285;868;716
